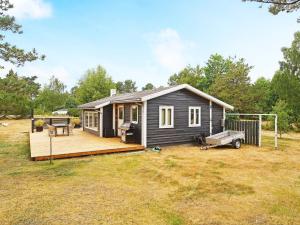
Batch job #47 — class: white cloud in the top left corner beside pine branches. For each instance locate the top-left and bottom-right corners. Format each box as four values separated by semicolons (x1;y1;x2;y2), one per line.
8;0;52;19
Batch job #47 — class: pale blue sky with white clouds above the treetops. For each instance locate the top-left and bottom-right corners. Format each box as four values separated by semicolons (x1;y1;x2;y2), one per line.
0;0;300;89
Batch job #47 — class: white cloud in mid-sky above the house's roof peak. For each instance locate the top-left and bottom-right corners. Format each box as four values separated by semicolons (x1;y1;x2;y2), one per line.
149;28;193;72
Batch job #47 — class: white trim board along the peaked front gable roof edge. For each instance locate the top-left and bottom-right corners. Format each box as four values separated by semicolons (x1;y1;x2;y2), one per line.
141;84;234;110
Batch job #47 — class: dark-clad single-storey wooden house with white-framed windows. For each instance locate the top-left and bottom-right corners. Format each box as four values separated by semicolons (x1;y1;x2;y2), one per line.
79;84;233;147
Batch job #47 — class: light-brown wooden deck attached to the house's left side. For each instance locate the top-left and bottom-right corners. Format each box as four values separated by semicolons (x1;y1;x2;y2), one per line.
30;129;145;161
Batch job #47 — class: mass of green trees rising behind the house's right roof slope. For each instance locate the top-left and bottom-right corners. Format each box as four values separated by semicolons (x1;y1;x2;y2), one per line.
168;54;256;112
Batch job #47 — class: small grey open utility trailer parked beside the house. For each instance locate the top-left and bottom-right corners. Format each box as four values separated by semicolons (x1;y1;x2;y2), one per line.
201;130;245;149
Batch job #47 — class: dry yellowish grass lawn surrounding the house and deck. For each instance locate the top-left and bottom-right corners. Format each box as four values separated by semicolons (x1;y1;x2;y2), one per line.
0;120;300;225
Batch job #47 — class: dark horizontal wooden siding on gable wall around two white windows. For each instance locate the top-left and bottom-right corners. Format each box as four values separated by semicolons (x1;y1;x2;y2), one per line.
147;89;209;147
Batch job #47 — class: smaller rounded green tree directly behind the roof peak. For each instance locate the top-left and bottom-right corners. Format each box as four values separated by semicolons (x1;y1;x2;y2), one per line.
168;65;207;90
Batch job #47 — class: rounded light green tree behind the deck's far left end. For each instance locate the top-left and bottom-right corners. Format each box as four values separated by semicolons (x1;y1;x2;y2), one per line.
36;76;68;114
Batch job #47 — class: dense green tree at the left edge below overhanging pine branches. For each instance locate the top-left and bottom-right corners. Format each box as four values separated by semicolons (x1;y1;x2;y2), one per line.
0;70;40;115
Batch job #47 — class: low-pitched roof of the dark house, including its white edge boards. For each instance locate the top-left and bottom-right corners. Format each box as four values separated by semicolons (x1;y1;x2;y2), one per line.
79;84;234;110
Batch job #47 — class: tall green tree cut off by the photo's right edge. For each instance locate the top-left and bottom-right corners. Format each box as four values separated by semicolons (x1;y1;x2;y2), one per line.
272;32;300;122
